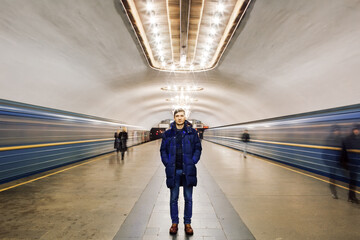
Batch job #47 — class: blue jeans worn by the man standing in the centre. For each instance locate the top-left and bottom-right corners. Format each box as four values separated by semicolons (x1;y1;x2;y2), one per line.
170;169;193;224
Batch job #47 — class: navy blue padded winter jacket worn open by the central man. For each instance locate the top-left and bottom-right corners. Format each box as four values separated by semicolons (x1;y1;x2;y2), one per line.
160;121;202;188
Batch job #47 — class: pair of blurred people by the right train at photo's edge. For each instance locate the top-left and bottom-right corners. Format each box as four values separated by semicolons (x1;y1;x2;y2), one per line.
323;125;360;204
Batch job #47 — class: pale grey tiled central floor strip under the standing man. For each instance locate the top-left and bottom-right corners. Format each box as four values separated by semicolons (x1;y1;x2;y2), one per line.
114;159;255;240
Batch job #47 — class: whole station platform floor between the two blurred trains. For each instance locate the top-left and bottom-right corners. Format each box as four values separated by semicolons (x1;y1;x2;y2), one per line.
0;141;360;240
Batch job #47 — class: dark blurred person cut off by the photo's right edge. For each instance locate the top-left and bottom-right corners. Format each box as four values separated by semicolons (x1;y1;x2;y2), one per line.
342;125;360;204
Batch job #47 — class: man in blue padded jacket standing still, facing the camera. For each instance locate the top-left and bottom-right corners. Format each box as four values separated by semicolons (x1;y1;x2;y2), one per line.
160;109;202;235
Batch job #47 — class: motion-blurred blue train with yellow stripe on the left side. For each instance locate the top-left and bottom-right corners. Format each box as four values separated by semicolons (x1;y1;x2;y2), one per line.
0;100;149;182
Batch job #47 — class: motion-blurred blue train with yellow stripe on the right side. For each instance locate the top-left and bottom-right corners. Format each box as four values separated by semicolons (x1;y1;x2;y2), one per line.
204;105;360;186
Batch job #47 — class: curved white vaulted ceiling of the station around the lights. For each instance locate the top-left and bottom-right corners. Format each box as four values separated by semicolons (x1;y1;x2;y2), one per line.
0;0;360;128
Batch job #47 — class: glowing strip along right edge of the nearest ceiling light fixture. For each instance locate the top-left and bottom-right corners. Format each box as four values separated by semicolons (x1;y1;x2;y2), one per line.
210;0;251;68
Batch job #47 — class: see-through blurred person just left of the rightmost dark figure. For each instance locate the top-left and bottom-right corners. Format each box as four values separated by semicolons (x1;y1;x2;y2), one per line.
322;125;342;199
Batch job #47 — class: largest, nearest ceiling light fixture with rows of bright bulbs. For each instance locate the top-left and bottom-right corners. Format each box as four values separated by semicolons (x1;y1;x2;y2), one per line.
119;0;251;73
